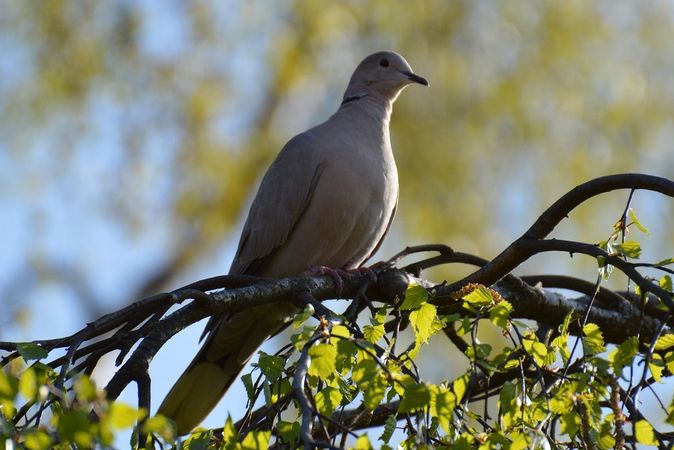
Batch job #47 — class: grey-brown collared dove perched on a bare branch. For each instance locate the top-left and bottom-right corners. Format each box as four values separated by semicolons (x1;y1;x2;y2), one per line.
158;51;429;435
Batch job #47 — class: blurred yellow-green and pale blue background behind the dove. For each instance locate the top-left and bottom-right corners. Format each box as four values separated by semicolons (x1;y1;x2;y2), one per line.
0;0;674;442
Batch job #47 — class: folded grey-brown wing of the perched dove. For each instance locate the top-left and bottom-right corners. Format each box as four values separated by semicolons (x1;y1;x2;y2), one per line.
229;130;321;276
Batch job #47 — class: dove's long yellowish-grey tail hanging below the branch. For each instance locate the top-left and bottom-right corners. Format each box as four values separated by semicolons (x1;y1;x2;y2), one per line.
157;305;292;435
